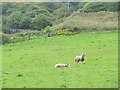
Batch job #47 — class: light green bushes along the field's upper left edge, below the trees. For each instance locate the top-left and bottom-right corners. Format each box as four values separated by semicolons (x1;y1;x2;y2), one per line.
2;30;44;44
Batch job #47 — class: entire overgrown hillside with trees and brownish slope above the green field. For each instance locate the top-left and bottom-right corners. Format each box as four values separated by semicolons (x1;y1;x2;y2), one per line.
0;2;118;44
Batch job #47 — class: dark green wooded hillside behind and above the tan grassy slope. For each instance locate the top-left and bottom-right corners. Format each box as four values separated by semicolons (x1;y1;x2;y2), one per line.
0;2;118;33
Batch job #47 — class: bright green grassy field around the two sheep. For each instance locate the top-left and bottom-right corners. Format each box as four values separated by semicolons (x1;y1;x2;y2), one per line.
2;32;118;88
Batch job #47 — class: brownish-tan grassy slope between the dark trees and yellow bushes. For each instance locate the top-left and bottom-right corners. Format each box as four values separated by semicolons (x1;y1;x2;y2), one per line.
53;12;118;31
